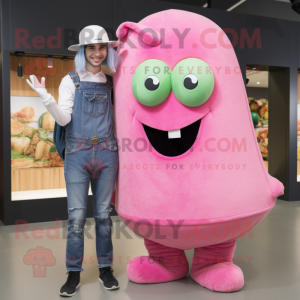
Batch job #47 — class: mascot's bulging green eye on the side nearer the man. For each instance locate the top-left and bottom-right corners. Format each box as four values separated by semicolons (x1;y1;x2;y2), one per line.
131;59;171;106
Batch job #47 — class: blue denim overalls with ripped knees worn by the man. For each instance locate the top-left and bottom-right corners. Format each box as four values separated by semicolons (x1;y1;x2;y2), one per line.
64;71;119;271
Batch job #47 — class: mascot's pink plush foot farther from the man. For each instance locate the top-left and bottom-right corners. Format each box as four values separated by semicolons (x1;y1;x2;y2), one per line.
191;262;244;292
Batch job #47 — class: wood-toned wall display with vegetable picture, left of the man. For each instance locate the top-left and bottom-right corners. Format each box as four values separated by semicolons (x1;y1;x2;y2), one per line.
10;52;97;201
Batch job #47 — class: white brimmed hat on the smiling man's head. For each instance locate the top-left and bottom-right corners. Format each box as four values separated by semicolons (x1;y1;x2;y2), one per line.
68;25;123;51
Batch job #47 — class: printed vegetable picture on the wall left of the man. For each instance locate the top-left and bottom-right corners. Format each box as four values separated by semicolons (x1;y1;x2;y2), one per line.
10;105;64;169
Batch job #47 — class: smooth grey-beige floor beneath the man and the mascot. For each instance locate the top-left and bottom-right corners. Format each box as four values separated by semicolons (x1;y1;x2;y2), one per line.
0;200;300;300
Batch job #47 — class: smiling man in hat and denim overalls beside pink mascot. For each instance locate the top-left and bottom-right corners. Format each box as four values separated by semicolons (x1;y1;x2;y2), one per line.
27;25;121;296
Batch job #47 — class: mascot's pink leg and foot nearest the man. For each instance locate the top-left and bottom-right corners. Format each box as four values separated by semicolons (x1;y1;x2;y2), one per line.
127;239;189;283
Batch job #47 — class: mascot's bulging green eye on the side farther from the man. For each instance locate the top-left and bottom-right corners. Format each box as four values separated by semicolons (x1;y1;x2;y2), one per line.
171;58;214;107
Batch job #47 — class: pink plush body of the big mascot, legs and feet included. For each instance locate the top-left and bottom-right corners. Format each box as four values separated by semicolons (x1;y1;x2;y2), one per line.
114;10;283;292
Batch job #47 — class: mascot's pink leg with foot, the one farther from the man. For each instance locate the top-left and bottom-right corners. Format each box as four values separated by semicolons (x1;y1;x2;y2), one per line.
191;240;244;292
